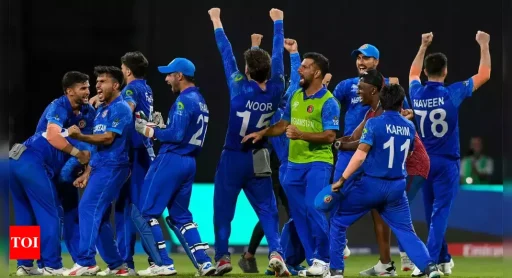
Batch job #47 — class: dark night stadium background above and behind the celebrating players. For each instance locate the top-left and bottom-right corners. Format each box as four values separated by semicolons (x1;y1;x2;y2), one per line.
9;0;506;251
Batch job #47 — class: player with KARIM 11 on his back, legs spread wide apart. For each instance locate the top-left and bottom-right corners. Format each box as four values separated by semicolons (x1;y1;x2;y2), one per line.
330;84;441;278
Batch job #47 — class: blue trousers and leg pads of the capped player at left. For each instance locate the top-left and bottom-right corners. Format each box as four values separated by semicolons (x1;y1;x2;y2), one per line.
139;152;210;265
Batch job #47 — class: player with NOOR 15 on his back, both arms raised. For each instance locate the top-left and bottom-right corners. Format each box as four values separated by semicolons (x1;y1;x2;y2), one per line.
208;8;289;276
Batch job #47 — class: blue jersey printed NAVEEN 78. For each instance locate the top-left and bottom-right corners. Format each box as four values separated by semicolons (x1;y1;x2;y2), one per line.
409;78;473;159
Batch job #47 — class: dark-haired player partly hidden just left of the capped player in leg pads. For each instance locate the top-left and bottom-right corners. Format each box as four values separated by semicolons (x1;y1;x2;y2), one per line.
110;51;155;276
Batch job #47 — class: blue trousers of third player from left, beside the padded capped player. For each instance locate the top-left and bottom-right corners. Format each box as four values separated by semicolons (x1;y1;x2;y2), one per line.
114;147;151;269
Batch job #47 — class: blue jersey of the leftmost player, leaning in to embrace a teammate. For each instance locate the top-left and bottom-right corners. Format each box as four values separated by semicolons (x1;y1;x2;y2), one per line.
36;95;96;134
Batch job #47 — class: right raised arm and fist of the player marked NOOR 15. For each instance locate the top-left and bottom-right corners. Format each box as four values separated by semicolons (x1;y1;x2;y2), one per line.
270;9;284;78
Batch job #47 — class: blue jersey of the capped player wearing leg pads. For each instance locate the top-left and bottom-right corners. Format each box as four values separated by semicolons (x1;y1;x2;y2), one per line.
154;87;209;157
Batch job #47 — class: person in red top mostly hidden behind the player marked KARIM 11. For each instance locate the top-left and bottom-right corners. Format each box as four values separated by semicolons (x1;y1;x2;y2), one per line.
331;69;430;276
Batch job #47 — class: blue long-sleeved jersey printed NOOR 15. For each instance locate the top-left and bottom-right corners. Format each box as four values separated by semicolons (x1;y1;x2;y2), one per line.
215;20;285;150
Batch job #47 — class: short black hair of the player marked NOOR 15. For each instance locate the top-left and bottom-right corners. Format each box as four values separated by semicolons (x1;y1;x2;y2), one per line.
244;48;271;83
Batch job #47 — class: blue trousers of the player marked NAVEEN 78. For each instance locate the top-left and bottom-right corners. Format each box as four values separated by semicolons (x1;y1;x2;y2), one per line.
423;155;460;264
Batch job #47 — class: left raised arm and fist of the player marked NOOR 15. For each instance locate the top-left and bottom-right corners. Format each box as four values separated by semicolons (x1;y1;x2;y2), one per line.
208;8;238;81
